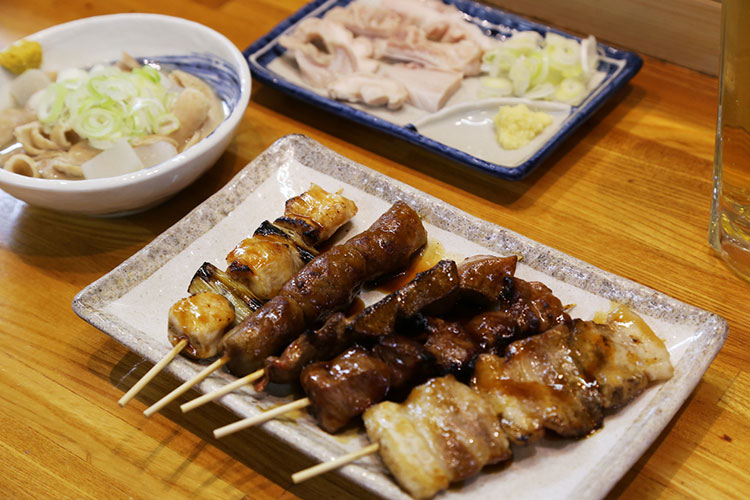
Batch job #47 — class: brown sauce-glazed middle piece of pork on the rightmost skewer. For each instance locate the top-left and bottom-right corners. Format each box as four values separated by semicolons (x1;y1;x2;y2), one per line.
471;324;603;444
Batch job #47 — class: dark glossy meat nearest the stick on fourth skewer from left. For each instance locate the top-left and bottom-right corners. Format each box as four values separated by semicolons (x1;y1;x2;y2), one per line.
300;336;432;432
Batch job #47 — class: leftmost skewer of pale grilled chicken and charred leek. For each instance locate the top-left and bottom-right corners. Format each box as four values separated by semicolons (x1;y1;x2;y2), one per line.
119;184;357;406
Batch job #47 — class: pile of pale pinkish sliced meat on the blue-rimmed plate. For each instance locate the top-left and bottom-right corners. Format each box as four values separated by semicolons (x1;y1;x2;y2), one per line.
279;0;497;112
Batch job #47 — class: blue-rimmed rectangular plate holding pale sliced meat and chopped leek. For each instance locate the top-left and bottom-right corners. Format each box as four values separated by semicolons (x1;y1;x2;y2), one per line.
243;0;643;180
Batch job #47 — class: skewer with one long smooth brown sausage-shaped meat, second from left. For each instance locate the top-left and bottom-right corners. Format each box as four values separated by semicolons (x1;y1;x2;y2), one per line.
144;202;427;416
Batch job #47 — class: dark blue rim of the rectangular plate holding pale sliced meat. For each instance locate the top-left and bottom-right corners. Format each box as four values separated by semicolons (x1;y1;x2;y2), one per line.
243;0;643;180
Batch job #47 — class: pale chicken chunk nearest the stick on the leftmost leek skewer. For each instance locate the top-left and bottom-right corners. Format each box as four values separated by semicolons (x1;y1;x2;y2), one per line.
168;292;235;358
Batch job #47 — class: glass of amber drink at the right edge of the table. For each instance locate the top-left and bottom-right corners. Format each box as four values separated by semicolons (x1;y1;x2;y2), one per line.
709;0;750;280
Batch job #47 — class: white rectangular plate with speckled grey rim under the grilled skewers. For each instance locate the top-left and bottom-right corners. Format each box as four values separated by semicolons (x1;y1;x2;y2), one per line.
73;135;727;500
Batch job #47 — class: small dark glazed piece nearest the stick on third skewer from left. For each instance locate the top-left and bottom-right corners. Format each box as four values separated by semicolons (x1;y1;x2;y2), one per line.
262;313;352;390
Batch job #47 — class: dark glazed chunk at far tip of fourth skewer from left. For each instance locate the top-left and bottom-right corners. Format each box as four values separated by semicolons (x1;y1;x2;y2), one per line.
464;276;570;355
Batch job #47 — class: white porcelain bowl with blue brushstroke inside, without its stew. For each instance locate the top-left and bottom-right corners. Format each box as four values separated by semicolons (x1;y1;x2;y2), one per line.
0;14;251;215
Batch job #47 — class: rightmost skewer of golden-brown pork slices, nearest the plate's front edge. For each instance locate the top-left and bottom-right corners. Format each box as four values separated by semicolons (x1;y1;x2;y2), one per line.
298;306;672;499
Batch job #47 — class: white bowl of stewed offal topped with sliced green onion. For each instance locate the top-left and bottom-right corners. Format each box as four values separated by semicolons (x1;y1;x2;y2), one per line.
0;14;250;215
